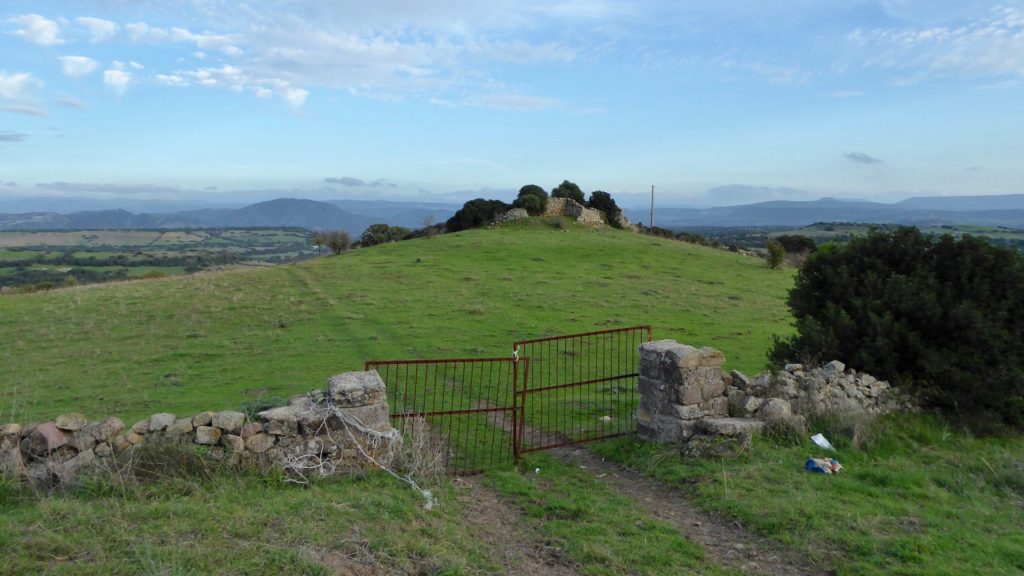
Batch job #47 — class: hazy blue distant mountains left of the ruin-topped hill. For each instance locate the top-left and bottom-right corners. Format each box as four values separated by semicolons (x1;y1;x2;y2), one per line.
0;198;461;236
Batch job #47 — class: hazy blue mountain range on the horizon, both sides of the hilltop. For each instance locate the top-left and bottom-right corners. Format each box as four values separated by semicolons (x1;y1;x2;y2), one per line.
0;194;1024;230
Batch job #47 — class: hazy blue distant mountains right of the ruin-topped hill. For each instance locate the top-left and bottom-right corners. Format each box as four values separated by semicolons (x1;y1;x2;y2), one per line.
626;194;1024;229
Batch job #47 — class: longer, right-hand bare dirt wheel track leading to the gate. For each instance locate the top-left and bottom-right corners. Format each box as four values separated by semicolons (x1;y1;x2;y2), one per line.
553;448;835;576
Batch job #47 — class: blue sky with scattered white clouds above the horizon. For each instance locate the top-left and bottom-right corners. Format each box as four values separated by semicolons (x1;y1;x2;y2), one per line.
0;0;1024;204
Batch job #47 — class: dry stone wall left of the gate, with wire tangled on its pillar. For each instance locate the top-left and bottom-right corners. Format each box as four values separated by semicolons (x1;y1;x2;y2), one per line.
0;372;401;487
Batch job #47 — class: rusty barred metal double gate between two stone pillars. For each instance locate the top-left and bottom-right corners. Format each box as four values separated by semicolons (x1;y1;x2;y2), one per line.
366;326;651;475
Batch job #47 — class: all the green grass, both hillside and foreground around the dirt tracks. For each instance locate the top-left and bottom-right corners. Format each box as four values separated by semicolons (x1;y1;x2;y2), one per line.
0;217;1024;574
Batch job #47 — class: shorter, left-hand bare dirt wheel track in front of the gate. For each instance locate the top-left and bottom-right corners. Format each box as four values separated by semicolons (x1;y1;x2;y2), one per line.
456;477;579;576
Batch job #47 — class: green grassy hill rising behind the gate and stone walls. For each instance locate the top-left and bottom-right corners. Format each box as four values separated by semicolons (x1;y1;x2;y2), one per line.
0;222;793;422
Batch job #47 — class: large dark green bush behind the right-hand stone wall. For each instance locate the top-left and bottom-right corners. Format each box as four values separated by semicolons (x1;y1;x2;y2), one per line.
770;228;1024;429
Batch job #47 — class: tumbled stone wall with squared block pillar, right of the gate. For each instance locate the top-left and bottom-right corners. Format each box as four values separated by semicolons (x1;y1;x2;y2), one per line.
637;340;898;454
